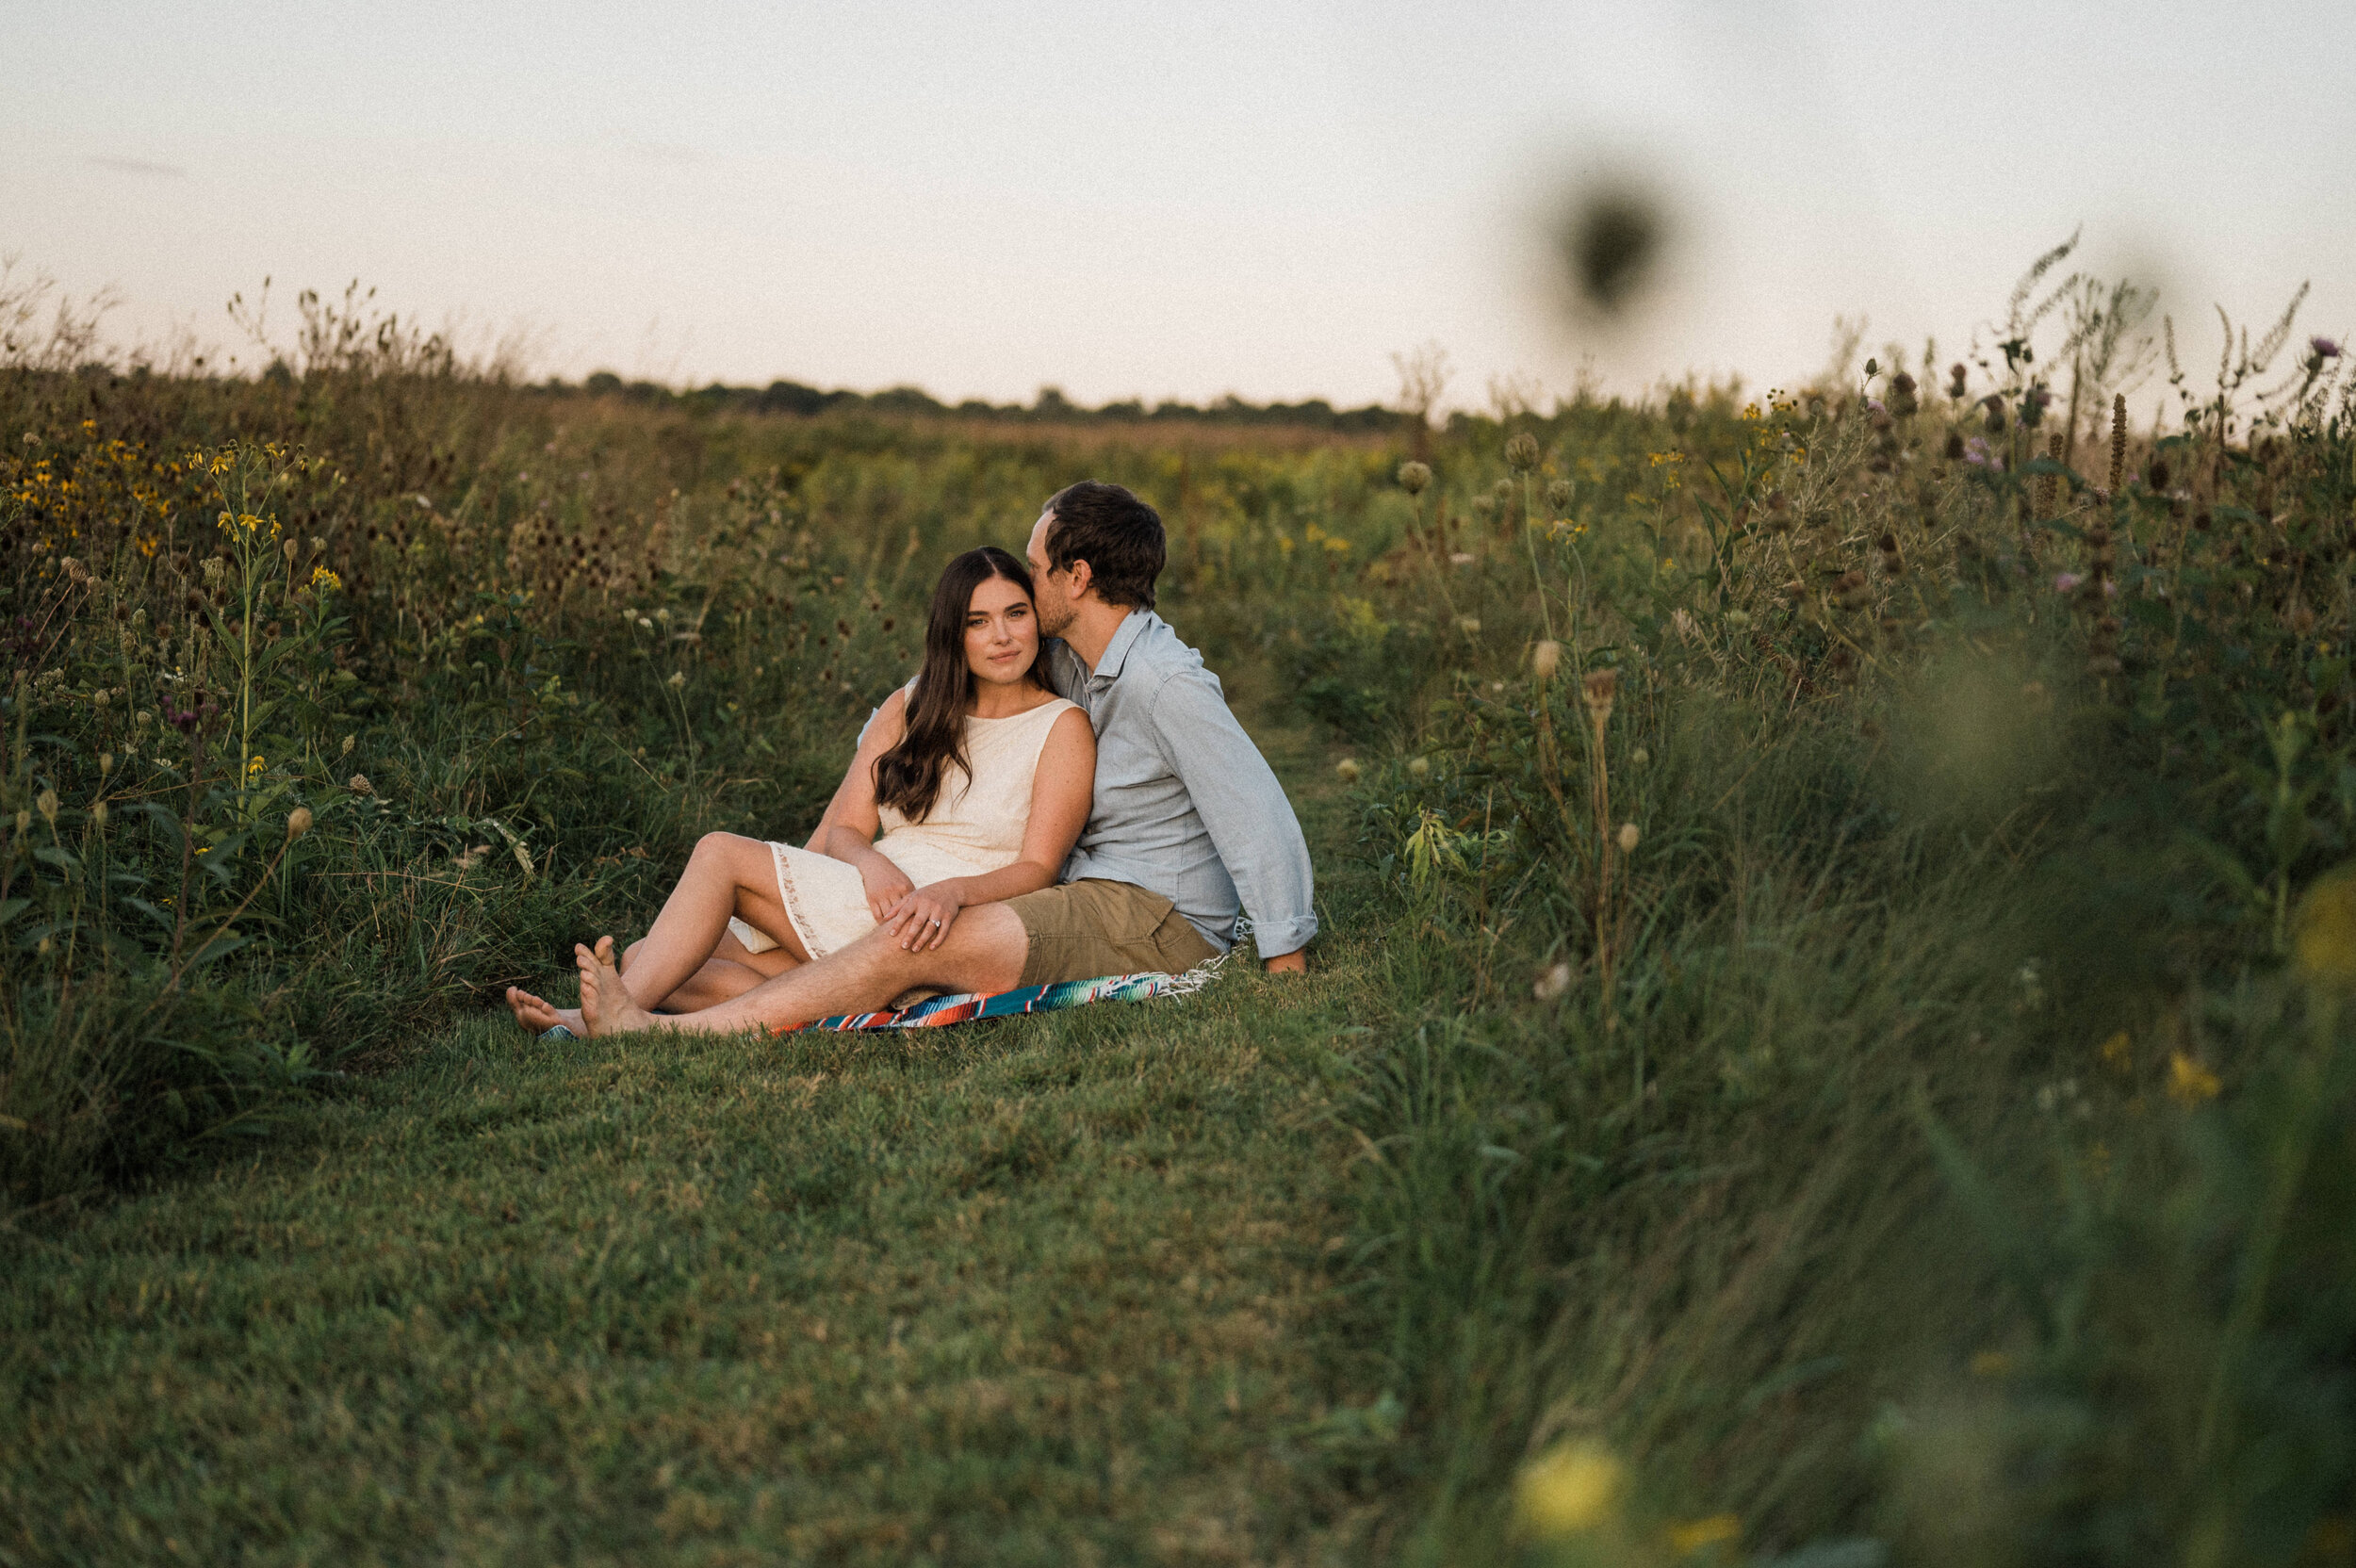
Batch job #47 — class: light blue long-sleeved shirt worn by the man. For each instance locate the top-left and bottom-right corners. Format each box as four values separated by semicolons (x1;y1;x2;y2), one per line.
1046;610;1317;958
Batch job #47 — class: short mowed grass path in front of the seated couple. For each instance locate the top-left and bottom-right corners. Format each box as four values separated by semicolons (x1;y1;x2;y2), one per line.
0;735;1385;1566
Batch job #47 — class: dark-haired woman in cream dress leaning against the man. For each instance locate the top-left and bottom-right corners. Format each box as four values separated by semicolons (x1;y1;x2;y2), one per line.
507;547;1096;1036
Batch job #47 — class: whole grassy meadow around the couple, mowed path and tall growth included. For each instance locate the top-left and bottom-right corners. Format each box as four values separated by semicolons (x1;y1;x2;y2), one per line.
0;252;2356;1568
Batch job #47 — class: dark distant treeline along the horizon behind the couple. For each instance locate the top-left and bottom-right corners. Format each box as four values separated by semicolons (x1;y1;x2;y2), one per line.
545;369;1402;431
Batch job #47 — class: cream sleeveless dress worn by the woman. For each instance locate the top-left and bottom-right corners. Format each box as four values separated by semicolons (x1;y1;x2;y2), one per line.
728;697;1072;958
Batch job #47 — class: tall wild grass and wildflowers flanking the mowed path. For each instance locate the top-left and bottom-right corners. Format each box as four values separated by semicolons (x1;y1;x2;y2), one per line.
0;254;2356;1568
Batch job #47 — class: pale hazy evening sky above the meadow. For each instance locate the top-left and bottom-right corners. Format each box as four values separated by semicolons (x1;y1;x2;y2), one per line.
0;0;2356;405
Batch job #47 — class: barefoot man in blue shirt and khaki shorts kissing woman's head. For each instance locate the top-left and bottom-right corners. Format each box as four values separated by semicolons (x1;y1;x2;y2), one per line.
575;481;1317;1034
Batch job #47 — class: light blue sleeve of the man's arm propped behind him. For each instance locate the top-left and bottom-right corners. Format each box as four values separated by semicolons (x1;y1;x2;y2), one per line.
1153;671;1317;958
